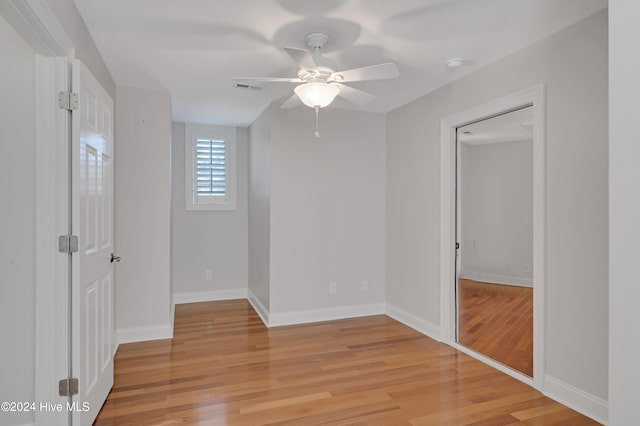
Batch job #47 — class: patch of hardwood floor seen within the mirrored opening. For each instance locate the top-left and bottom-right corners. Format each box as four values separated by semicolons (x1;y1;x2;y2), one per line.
458;279;533;377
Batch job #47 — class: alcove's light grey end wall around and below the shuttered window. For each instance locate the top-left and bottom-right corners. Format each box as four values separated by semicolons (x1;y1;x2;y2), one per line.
171;123;249;301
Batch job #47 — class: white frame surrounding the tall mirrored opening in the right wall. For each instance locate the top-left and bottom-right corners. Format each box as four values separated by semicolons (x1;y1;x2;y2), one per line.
440;84;546;391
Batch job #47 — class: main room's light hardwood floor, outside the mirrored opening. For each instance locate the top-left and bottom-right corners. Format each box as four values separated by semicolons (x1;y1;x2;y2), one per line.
95;300;597;426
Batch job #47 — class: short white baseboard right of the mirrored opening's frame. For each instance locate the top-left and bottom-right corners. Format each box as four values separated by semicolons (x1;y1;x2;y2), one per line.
544;374;609;425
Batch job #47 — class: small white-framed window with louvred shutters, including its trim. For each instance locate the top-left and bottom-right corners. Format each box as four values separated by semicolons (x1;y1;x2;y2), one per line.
185;124;236;210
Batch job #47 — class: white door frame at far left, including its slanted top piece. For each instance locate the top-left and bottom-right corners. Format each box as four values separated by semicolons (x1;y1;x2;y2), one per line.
0;0;75;425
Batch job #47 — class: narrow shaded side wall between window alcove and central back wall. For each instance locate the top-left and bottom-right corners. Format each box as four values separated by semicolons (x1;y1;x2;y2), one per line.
249;106;274;314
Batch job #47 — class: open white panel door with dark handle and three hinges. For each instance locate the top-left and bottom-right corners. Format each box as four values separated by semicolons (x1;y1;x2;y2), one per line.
72;61;115;425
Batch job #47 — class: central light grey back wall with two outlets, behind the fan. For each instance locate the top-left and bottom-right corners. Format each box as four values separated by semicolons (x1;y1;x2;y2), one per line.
270;108;386;314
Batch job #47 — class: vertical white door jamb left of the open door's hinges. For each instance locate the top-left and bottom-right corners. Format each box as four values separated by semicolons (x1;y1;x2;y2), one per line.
35;55;72;426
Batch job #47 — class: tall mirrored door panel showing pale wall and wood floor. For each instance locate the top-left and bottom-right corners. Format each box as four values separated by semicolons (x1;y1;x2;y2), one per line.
455;106;534;377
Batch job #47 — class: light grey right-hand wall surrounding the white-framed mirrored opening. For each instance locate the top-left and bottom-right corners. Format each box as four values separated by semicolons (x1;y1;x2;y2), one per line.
387;11;608;400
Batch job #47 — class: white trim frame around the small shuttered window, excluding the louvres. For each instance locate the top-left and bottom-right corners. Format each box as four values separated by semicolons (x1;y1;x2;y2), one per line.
184;123;237;211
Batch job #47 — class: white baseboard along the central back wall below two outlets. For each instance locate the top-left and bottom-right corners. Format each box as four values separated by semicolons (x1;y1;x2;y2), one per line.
268;303;385;327
